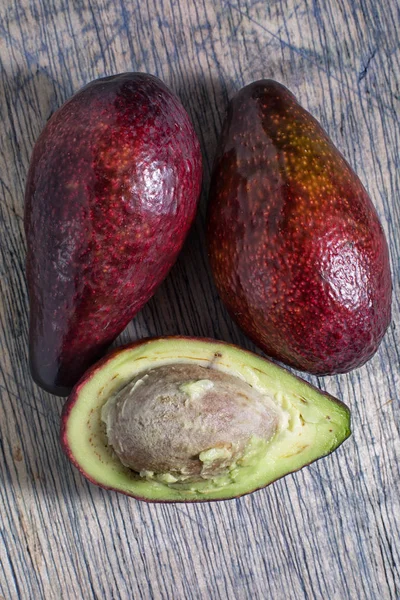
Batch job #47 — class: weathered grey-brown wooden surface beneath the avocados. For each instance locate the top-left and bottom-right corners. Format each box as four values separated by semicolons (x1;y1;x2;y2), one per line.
0;0;400;600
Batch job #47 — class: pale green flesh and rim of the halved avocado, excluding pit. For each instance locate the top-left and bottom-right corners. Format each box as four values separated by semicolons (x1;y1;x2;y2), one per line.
61;337;351;502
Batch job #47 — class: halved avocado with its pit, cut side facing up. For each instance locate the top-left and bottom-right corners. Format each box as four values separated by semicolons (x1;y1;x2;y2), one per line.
60;337;350;502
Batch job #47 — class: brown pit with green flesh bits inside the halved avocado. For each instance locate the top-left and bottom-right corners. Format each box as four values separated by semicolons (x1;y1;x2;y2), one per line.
101;364;280;484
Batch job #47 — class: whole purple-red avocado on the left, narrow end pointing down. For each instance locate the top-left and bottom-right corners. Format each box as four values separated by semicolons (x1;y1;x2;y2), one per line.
25;73;202;396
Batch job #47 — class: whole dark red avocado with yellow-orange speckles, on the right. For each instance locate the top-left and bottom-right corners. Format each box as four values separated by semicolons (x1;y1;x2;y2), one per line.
208;80;392;375
